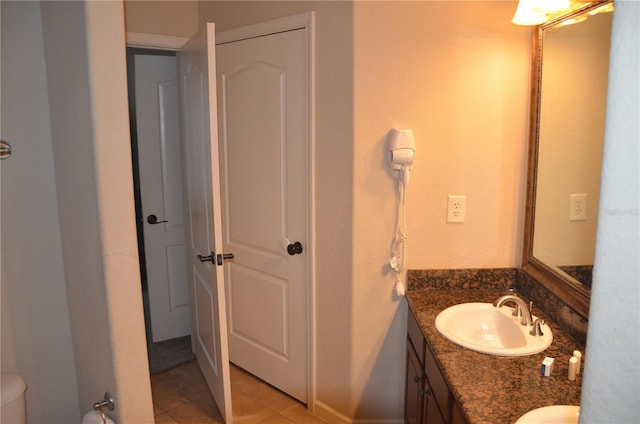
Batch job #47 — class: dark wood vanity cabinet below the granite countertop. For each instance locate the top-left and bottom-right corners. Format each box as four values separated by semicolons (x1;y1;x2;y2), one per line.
405;311;466;424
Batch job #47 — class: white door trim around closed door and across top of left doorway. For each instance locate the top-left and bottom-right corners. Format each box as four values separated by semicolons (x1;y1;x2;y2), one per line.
126;12;316;411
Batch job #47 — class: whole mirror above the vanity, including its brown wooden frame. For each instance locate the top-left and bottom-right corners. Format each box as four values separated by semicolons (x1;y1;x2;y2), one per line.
522;0;613;318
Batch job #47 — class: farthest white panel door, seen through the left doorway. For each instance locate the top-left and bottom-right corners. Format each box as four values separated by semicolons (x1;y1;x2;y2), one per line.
134;55;191;342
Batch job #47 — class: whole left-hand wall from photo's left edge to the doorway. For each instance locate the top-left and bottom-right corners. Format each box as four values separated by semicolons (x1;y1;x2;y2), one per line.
1;2;153;423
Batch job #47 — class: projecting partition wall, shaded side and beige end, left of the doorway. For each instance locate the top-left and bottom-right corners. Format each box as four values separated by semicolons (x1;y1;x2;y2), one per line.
41;1;153;423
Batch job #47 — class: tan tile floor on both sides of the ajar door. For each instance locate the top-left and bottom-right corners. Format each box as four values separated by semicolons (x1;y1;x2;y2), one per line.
151;361;325;424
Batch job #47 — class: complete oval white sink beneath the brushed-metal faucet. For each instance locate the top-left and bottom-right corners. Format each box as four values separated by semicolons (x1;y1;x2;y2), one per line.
436;303;553;356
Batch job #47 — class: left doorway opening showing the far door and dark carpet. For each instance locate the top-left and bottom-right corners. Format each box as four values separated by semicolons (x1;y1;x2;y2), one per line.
127;47;195;374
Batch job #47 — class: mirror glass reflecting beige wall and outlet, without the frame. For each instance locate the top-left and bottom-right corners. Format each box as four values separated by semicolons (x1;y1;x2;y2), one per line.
532;3;613;289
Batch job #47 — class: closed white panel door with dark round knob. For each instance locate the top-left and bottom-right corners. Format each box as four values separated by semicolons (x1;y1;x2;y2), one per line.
217;29;309;403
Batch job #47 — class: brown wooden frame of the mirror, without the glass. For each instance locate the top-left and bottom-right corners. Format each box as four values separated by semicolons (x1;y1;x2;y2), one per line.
522;0;612;319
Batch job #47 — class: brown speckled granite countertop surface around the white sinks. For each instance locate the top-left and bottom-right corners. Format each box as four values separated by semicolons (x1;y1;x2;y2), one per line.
406;289;584;424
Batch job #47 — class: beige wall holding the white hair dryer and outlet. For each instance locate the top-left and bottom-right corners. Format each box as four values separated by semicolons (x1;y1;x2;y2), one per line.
352;1;530;417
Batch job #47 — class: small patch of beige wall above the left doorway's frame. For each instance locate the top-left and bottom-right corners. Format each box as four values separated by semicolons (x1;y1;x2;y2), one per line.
124;0;198;38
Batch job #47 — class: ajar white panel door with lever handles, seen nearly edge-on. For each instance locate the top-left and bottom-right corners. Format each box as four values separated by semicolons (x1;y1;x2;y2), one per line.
178;24;232;422
